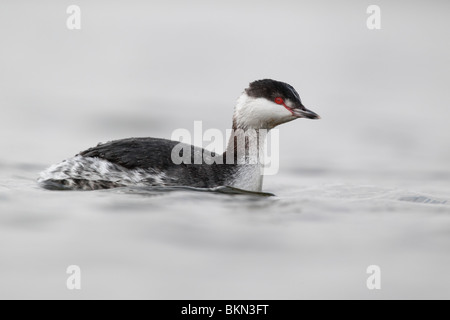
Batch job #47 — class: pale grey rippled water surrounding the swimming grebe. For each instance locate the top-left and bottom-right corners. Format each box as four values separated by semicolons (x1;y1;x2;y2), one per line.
0;0;450;299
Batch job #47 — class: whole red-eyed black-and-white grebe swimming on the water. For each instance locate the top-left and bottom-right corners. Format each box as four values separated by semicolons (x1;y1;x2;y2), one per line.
39;80;318;191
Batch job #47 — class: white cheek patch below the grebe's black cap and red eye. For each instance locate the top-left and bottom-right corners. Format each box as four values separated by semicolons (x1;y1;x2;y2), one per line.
235;93;295;129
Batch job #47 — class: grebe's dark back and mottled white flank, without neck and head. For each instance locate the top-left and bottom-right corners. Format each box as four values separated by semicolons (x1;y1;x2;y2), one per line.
38;138;241;190
